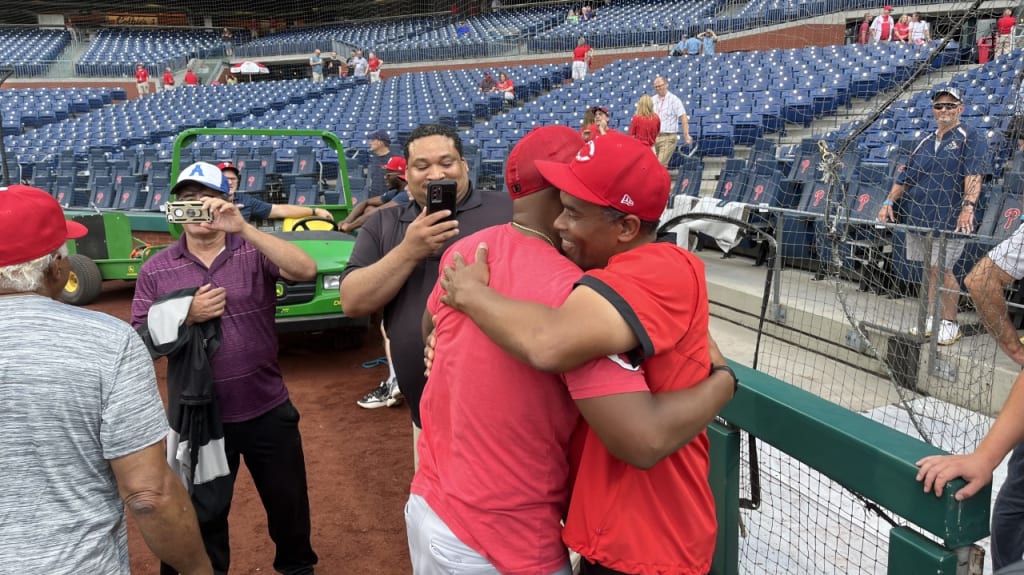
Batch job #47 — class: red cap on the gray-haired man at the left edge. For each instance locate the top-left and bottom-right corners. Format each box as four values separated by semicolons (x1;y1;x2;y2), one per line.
0;184;89;266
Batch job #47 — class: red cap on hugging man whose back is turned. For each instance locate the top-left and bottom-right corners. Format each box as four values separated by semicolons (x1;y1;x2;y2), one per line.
505;126;584;200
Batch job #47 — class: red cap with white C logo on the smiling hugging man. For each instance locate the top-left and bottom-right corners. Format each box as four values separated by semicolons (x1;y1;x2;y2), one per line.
537;132;672;222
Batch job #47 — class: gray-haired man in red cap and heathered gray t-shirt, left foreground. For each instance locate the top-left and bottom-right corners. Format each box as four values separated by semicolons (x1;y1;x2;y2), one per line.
0;185;212;575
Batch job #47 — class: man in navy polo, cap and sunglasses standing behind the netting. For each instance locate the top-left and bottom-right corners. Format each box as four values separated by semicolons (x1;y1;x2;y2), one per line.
879;88;988;346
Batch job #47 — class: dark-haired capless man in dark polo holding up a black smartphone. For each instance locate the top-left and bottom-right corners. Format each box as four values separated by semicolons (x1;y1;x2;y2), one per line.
339;124;512;465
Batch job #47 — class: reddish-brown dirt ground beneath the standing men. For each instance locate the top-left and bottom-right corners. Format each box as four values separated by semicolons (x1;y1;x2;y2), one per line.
89;281;413;575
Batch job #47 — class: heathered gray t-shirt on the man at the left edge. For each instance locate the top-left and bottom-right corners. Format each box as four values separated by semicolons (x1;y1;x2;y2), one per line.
0;296;167;575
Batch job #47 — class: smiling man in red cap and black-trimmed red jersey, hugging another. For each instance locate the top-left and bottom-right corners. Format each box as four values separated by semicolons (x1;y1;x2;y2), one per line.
441;132;734;575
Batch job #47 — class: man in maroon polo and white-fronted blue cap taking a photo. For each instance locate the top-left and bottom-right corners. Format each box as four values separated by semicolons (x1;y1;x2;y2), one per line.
131;162;317;574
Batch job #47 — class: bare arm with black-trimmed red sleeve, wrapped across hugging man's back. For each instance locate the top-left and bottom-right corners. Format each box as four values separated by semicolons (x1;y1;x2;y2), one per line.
441;246;639;372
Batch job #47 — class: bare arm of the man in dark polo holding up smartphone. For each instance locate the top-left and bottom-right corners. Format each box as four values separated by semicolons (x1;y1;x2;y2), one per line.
339;210;459;317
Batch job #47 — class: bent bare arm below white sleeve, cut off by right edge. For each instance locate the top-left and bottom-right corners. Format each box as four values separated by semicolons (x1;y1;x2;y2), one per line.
964;256;1024;365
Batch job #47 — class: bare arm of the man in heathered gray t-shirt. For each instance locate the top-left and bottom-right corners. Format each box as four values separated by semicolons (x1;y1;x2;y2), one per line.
111;443;213;575
